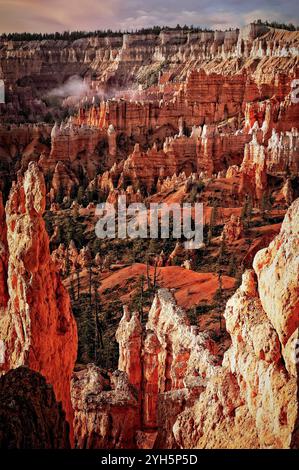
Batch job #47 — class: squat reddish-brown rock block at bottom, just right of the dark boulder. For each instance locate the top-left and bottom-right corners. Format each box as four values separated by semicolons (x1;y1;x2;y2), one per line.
72;364;140;449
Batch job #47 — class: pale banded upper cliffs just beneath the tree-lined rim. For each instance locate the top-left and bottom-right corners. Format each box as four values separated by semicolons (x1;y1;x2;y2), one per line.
0;24;298;124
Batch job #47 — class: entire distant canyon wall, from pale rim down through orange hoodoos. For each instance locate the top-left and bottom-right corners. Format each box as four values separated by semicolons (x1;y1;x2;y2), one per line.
0;24;299;203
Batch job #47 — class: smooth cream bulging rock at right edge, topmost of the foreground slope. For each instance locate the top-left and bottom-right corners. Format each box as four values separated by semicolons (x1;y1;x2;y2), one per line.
253;199;299;362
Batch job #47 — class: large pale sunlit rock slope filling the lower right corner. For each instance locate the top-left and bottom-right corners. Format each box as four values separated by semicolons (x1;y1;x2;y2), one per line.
173;200;299;448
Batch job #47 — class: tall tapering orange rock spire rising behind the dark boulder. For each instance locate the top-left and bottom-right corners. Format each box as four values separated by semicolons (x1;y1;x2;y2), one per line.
0;163;77;436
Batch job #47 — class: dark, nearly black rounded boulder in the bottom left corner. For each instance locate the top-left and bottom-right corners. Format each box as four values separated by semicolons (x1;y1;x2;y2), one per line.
0;367;70;449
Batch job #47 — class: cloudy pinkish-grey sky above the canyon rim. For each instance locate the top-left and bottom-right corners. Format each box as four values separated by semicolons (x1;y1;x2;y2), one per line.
0;0;299;33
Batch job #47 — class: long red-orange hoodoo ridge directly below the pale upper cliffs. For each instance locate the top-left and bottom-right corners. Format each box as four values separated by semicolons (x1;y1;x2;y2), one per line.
74;68;297;138
